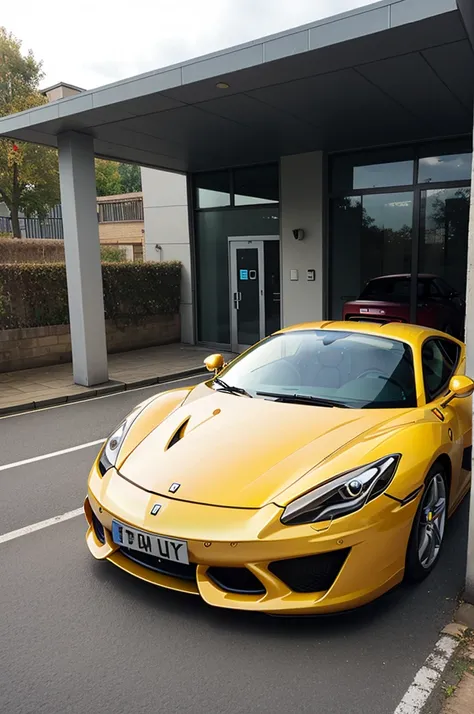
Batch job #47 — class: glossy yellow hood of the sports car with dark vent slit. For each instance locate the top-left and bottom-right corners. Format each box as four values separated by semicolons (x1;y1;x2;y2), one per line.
120;384;413;508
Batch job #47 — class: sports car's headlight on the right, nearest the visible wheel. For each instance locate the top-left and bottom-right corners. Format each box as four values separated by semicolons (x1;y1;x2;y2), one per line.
281;454;401;525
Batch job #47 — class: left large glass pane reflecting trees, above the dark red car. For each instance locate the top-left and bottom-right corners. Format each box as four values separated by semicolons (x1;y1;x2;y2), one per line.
331;192;413;319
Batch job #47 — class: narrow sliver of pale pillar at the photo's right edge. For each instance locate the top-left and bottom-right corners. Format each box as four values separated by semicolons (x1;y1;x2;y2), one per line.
464;126;474;605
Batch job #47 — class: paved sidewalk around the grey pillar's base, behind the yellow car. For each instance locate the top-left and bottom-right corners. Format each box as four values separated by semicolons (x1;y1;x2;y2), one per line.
0;344;235;416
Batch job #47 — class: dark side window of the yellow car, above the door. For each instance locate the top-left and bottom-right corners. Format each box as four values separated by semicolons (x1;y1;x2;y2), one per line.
421;339;459;401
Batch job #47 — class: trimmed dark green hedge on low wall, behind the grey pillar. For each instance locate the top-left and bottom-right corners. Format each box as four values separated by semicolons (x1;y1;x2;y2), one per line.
0;261;181;329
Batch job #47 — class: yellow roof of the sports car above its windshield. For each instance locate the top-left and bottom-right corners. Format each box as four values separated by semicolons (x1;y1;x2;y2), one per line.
280;320;459;345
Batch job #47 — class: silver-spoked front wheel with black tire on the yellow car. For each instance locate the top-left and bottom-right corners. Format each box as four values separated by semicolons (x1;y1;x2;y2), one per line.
405;462;448;582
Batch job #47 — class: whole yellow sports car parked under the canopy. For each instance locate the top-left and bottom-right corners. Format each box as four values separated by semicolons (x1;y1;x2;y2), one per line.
85;322;474;614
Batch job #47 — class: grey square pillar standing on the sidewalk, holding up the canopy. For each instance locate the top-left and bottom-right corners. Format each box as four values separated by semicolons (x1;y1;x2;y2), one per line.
58;132;108;387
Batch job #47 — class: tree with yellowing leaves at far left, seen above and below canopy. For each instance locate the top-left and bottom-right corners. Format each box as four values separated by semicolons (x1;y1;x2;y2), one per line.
0;27;59;238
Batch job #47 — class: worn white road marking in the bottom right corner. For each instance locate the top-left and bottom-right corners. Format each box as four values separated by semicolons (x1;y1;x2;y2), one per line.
394;635;459;714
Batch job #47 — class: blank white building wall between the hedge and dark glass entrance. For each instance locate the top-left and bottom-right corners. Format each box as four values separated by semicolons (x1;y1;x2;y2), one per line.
141;168;194;344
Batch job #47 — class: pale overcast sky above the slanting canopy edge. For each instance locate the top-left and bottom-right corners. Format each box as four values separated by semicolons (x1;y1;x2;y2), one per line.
0;0;369;89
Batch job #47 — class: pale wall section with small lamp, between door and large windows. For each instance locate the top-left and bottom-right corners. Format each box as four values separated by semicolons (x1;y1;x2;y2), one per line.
280;152;324;327
